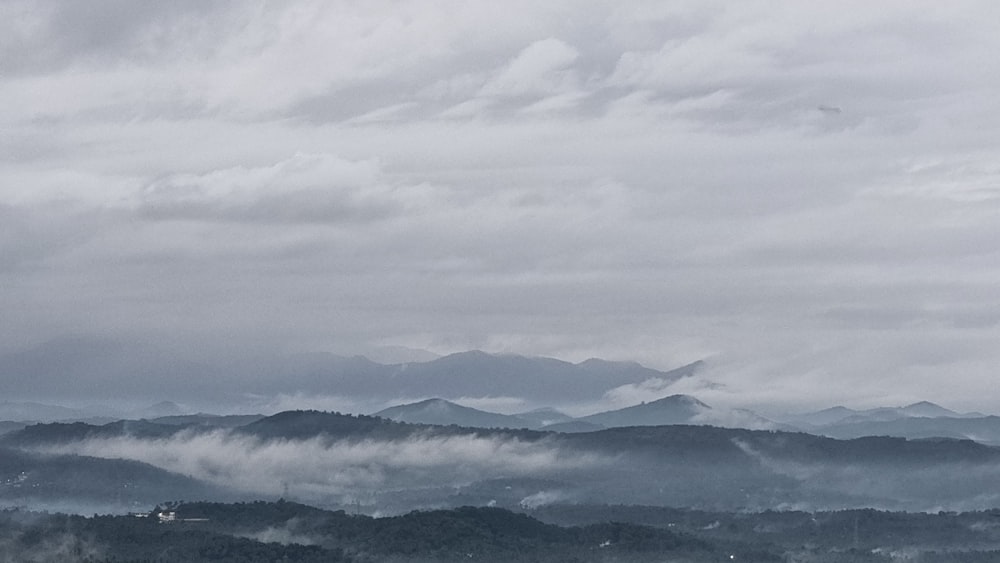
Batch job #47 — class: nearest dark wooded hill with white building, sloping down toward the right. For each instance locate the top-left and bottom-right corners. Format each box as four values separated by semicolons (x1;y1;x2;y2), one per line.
0;501;736;563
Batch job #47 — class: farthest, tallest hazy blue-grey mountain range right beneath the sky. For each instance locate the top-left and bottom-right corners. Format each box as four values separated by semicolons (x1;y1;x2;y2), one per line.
0;338;702;408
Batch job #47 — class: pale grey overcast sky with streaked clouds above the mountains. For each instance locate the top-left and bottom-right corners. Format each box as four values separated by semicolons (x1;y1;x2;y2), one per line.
0;0;1000;412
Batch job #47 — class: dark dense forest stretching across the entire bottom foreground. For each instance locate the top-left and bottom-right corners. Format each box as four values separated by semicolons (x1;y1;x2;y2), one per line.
0;500;1000;563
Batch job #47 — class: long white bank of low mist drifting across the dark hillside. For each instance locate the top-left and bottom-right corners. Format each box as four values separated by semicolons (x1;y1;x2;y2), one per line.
39;431;608;499
